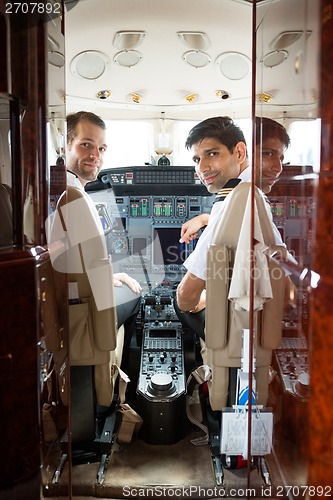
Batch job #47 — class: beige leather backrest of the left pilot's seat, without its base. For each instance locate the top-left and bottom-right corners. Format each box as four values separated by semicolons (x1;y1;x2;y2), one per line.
49;186;122;406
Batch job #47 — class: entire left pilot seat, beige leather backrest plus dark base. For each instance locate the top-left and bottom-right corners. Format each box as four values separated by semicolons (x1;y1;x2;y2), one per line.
49;186;126;475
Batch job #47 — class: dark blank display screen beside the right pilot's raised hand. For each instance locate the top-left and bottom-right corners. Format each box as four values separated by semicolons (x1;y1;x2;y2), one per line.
153;227;187;266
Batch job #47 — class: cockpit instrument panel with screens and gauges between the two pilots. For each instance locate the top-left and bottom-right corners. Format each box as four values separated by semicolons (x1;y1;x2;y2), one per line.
90;185;214;291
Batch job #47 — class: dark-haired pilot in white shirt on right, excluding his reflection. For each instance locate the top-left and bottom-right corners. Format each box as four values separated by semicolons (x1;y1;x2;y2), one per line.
174;116;251;337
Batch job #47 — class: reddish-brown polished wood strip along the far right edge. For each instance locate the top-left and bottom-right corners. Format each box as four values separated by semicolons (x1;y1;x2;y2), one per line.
308;0;333;487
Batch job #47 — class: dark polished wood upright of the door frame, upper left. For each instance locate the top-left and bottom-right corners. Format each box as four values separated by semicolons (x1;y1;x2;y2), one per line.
10;16;48;245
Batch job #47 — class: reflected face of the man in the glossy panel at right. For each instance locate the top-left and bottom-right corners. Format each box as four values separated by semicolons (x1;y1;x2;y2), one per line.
256;137;286;194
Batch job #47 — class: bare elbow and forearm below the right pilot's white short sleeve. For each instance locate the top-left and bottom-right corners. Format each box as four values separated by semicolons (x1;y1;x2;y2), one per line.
177;271;206;312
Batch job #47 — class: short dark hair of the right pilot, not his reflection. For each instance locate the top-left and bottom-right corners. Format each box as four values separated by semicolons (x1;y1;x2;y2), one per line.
185;116;246;153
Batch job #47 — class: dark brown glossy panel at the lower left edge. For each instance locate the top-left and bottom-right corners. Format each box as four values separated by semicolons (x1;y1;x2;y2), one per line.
0;252;40;499
